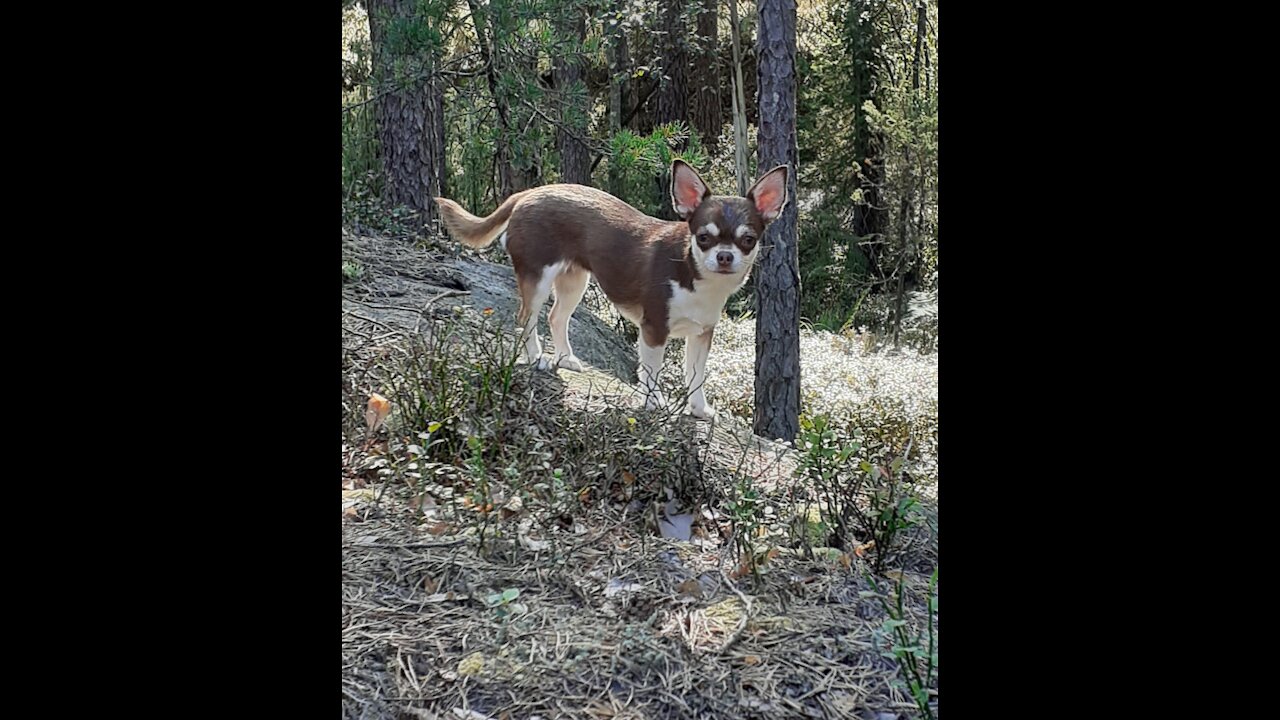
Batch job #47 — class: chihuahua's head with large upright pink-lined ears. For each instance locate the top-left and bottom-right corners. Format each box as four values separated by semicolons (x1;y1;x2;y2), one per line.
671;160;788;275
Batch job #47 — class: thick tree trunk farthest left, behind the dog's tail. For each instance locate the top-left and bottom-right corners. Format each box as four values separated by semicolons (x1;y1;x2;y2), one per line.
369;0;444;225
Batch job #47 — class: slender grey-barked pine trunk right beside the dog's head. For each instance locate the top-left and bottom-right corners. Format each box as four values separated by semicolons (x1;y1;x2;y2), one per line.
754;0;800;441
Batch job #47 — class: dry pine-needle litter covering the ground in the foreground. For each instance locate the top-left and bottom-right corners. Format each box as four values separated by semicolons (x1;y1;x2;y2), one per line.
343;479;936;717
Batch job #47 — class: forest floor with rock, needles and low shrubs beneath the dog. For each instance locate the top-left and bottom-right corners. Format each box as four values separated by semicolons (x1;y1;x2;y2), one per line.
342;228;938;720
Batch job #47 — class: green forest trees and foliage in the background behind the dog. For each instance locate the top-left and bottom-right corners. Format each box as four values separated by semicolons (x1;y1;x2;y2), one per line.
342;0;938;351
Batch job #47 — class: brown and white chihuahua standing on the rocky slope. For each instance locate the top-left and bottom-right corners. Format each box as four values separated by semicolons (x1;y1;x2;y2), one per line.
435;160;788;418
